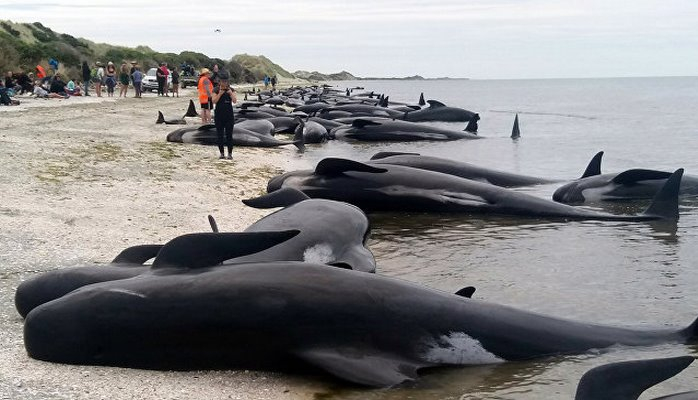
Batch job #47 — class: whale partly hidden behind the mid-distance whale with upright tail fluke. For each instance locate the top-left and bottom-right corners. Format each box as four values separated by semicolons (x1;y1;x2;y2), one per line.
369;152;560;187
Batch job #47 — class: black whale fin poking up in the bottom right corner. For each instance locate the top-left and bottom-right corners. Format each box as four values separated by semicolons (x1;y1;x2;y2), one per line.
574;356;693;400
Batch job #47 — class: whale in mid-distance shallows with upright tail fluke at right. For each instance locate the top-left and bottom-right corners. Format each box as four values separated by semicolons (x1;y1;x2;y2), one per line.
267;158;683;221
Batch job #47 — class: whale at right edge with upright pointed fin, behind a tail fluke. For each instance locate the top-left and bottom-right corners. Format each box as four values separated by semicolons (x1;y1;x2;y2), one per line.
553;151;698;203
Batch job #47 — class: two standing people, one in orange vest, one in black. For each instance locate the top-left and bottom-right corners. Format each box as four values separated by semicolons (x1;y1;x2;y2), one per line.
197;64;237;160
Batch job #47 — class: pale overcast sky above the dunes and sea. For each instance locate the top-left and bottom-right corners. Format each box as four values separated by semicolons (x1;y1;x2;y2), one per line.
0;0;698;79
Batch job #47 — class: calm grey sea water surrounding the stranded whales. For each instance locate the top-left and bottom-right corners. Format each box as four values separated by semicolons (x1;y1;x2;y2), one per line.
293;77;698;399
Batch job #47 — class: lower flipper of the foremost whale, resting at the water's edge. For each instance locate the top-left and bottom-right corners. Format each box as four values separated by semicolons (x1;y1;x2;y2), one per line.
296;348;429;387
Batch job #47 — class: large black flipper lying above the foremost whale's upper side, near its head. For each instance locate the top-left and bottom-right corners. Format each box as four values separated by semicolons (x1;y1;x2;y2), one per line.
153;229;300;269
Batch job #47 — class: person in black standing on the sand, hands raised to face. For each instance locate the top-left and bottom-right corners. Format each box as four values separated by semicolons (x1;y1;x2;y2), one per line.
212;70;237;160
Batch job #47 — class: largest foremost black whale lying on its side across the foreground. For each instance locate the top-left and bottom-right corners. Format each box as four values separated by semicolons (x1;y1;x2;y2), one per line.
24;262;696;387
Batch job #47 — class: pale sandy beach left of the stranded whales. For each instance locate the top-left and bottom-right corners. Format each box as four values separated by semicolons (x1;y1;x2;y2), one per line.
0;89;328;400
